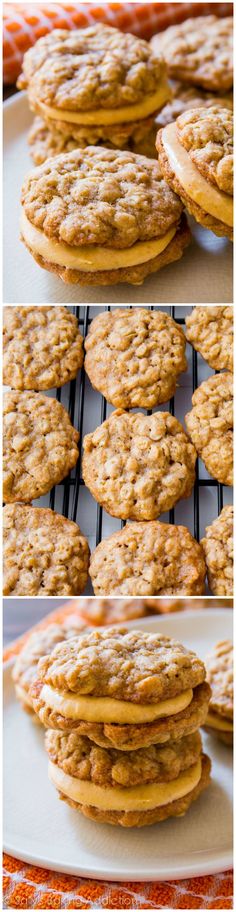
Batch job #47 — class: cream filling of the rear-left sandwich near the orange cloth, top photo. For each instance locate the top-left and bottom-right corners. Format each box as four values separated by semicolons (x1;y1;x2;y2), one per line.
37;80;170;126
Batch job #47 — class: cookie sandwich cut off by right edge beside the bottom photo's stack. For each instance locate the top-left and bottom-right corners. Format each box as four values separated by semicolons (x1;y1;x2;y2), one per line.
204;640;234;745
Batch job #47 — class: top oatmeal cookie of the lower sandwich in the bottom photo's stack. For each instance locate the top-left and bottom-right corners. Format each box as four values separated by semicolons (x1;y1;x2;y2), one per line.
45;729;202;788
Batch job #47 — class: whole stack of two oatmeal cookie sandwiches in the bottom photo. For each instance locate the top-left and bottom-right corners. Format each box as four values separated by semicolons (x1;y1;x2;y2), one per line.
30;628;210;827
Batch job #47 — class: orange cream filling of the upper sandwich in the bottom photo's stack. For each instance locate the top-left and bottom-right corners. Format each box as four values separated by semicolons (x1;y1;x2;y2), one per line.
41;684;193;725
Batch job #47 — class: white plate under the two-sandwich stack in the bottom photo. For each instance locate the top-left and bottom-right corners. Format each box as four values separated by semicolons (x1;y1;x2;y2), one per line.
4;609;232;881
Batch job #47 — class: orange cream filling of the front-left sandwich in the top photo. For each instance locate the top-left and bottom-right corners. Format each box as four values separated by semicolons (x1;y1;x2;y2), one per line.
21;211;177;272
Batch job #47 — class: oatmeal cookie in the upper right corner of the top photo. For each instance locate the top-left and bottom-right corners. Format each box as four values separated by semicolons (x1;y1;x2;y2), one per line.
151;16;233;94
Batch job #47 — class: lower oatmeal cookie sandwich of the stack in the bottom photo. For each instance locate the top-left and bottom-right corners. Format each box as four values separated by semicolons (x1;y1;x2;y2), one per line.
45;730;210;827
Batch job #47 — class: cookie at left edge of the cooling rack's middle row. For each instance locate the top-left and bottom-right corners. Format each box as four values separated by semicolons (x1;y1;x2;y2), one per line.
3;390;79;503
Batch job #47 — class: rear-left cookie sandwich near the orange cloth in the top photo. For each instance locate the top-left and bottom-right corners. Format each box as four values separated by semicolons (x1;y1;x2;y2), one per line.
18;24;170;157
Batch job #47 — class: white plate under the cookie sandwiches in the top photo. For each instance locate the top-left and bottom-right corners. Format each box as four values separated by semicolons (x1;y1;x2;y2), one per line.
4;93;233;304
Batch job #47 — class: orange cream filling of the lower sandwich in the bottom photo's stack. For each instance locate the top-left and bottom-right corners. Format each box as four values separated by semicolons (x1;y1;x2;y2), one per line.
48;758;202;811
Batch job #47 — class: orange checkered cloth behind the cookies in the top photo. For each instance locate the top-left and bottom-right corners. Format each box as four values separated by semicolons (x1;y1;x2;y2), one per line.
3;2;233;85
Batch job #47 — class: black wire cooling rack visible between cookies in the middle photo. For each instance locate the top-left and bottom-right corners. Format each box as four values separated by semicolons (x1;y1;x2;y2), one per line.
45;305;230;564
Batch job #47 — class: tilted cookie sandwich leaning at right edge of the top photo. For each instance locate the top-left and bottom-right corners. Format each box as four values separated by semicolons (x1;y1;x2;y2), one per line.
157;105;233;240
